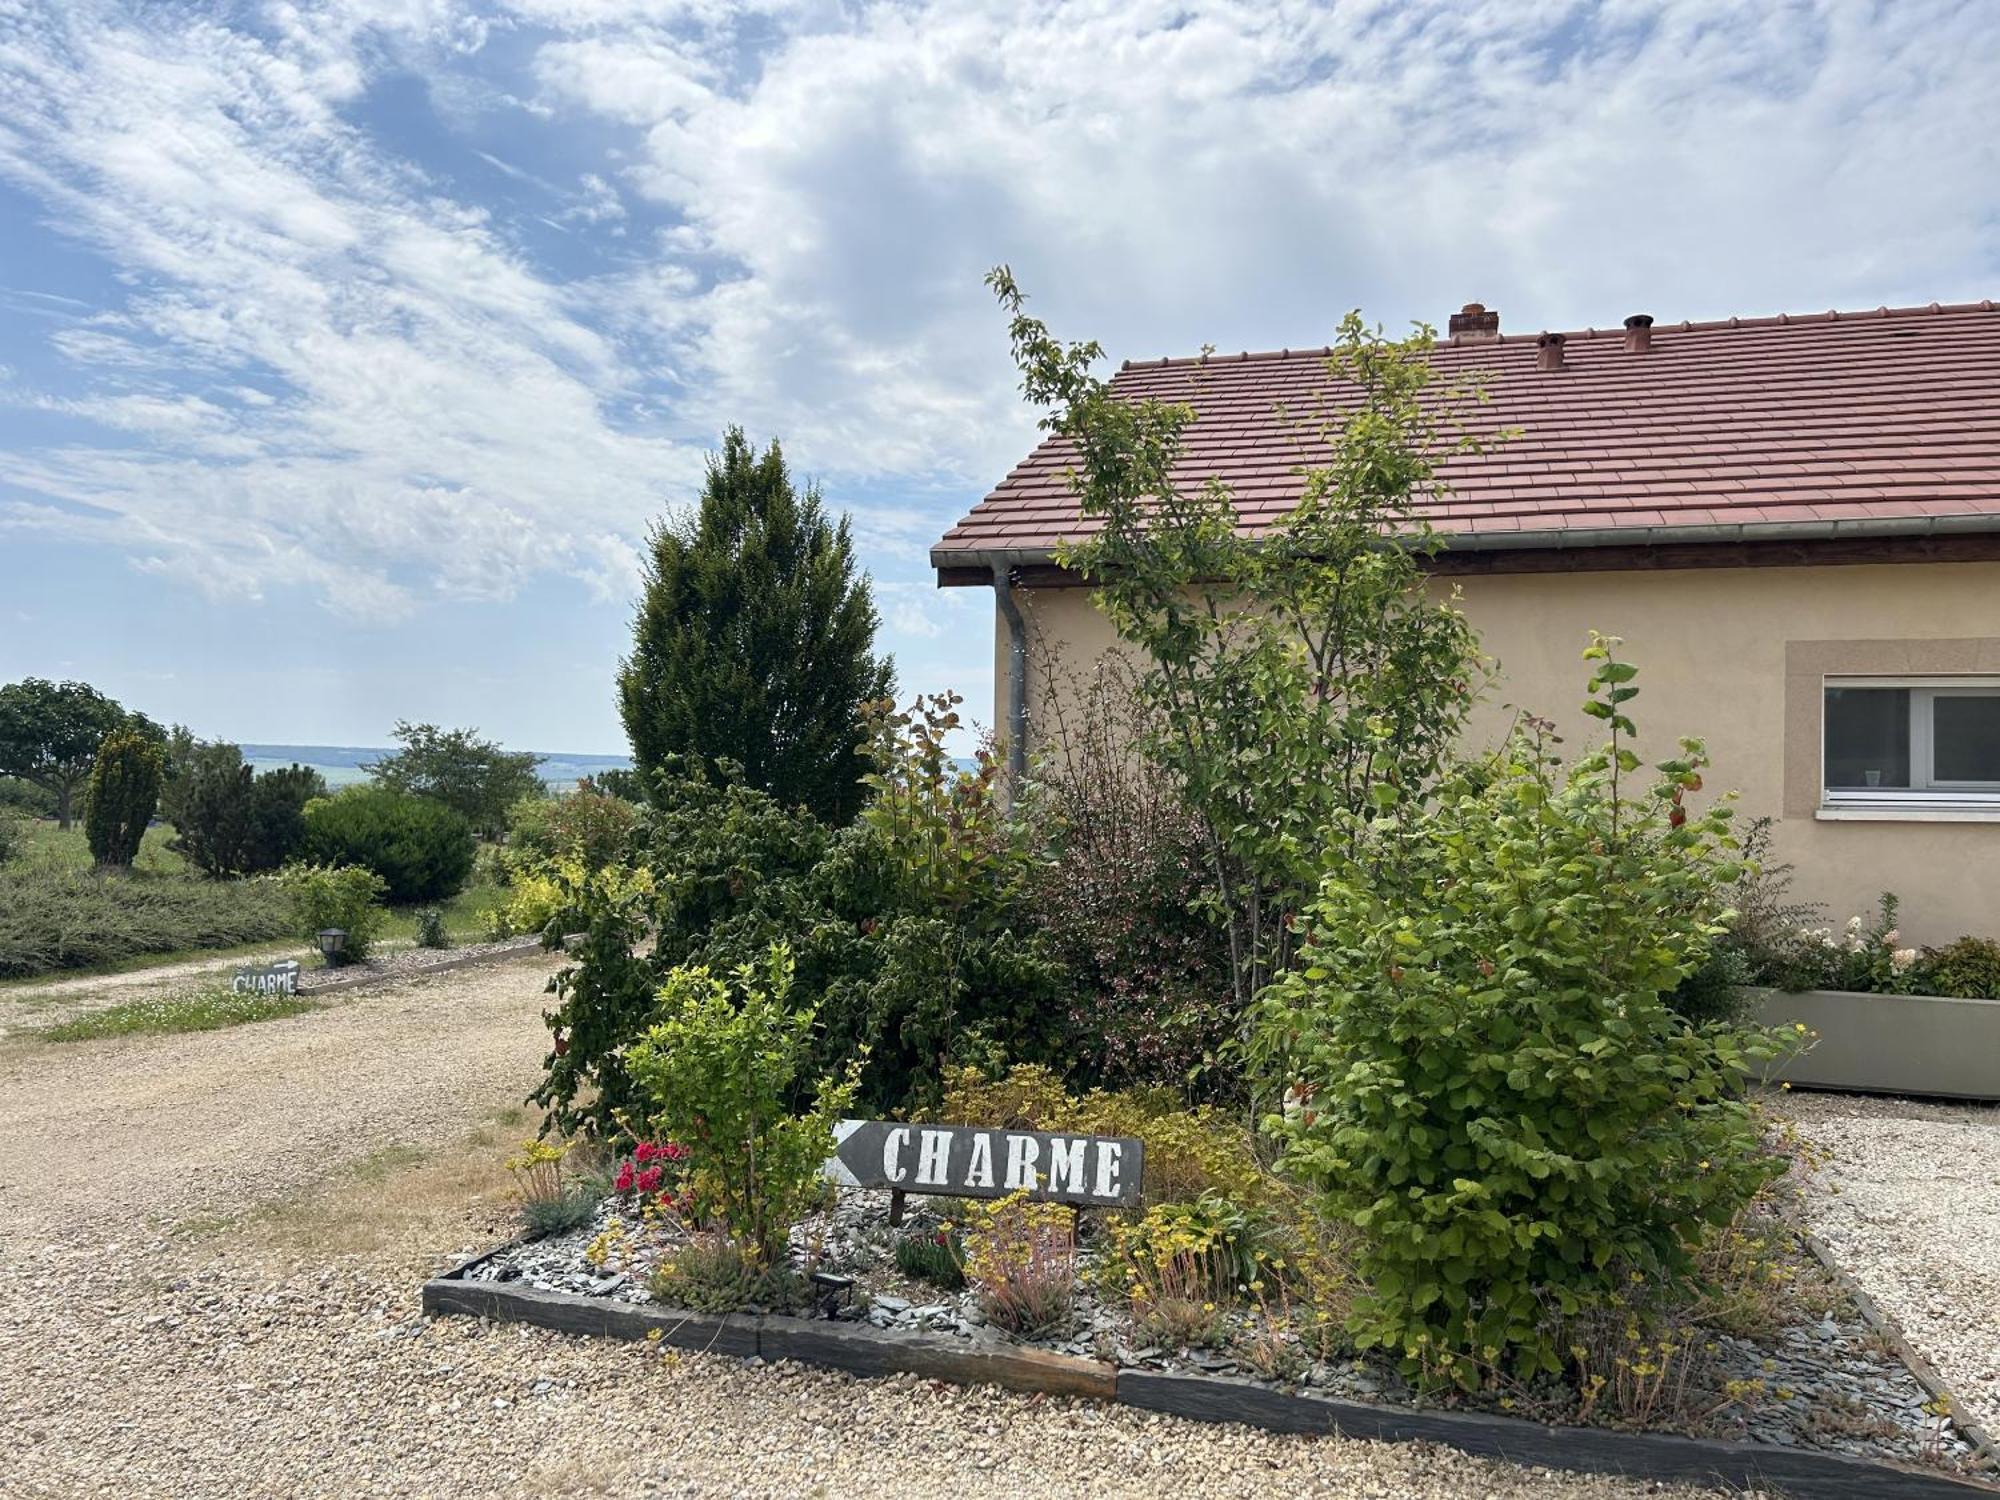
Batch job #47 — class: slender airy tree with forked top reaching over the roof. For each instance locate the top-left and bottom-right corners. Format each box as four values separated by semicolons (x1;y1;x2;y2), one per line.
988;268;1480;1014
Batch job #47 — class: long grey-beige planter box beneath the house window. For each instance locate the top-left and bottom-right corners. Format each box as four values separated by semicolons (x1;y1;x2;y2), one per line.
1750;990;2000;1100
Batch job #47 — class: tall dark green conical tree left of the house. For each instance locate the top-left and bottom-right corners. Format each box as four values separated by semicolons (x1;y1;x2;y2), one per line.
618;428;894;826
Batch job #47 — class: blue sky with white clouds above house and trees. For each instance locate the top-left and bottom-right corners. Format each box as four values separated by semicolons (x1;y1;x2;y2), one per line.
0;0;2000;754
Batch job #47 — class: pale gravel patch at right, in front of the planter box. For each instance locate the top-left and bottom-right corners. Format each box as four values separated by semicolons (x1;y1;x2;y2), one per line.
1784;1092;2000;1432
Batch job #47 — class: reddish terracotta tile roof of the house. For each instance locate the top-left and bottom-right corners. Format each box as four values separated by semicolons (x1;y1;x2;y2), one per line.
932;302;2000;568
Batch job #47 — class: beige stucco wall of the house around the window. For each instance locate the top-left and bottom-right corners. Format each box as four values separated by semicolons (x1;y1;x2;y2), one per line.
994;562;2000;944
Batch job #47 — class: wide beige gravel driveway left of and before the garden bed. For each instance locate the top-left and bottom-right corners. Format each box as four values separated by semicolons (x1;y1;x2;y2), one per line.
0;958;1736;1500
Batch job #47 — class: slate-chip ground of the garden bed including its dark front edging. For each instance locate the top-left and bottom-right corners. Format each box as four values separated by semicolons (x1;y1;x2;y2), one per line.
424;1190;1996;1496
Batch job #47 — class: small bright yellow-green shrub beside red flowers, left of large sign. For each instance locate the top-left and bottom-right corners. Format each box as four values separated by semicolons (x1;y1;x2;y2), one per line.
630;946;854;1264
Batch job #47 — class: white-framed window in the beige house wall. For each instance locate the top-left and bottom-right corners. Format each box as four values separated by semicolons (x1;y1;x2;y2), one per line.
1822;678;2000;812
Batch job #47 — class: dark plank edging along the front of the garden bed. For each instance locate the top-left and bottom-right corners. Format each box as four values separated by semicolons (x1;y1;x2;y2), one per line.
424;1246;2000;1500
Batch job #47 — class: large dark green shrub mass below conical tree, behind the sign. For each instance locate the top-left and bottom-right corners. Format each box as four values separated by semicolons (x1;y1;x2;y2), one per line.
536;700;1064;1132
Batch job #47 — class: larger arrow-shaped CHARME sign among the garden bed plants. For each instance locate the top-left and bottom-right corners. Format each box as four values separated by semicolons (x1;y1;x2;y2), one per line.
826;1120;1146;1224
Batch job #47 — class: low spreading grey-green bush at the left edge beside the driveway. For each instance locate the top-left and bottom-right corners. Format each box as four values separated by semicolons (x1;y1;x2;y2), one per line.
0;860;292;978
